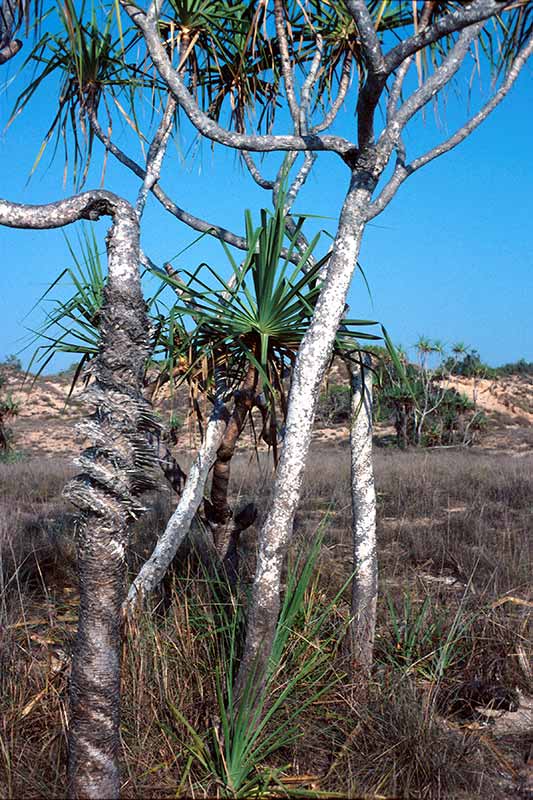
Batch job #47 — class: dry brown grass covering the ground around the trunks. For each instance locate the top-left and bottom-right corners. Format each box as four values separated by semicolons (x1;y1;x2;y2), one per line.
0;447;533;798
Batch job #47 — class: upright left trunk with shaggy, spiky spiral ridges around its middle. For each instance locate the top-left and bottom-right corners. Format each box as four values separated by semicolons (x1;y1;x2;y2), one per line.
65;208;156;798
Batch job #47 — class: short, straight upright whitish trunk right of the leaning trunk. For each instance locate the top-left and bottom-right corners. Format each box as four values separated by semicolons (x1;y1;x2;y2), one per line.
349;355;378;677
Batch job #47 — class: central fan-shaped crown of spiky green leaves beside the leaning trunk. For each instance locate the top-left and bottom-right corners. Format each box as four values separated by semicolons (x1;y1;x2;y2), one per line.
153;198;380;413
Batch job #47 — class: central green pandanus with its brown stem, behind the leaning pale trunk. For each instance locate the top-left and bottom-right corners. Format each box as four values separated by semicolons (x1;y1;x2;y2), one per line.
153;203;379;572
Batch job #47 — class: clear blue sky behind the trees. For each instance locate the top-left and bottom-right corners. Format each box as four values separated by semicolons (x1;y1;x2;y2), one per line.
0;40;533;367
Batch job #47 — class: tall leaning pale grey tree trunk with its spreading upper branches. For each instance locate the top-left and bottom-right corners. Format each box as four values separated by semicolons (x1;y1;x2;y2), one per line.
120;0;533;708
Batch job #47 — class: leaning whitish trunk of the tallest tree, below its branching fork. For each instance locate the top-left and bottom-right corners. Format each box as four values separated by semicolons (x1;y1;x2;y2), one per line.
235;171;375;699
